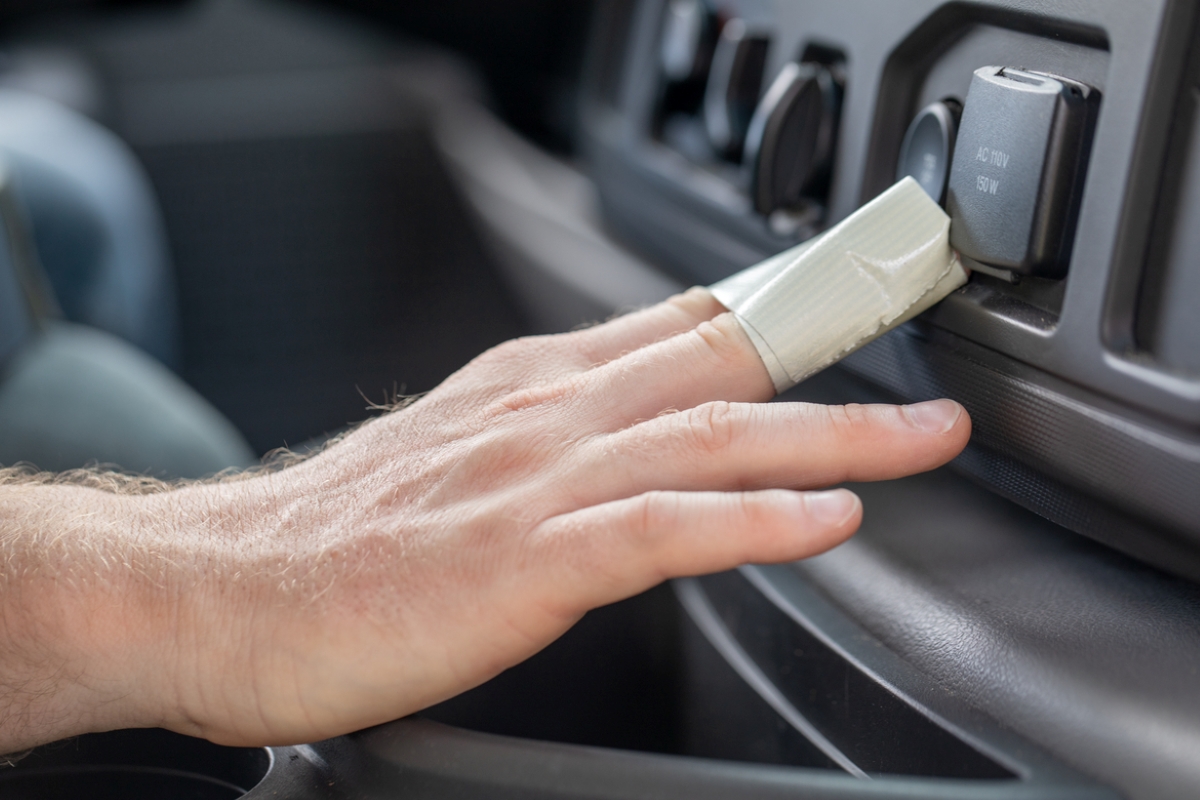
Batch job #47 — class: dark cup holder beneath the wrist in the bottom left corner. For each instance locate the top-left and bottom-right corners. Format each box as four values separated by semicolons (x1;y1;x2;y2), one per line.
0;730;272;800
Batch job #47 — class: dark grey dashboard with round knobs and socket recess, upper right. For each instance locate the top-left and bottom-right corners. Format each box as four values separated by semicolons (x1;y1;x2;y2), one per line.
583;2;1200;576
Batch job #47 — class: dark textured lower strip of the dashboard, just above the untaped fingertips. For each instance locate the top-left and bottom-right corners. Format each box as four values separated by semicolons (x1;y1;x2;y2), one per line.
842;327;1200;579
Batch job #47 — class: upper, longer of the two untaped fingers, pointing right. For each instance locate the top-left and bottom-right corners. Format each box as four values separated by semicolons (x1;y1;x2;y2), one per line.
558;399;971;503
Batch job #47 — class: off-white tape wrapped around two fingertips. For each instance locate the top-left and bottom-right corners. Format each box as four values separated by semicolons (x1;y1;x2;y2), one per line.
709;178;967;392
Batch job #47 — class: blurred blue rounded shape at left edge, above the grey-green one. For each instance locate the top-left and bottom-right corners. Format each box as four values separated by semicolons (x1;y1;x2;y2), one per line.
0;89;179;367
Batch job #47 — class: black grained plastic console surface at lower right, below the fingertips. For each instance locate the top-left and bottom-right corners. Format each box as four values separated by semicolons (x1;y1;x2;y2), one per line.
760;374;1200;800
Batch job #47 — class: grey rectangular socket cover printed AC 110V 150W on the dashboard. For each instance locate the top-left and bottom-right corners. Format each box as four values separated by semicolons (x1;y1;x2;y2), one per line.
947;67;1099;278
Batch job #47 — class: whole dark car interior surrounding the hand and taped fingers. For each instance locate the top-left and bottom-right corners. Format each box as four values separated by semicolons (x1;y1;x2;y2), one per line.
0;0;1200;800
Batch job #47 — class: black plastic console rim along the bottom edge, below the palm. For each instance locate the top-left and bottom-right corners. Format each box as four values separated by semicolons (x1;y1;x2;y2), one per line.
353;720;1115;800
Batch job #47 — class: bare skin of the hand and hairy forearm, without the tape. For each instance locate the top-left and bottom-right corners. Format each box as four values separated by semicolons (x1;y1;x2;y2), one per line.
0;289;971;752
